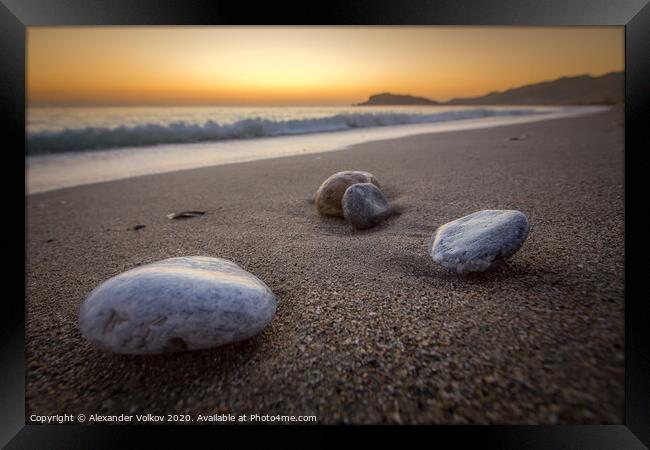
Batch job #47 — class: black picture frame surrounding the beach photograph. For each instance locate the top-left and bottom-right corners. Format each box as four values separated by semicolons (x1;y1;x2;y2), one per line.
0;0;650;449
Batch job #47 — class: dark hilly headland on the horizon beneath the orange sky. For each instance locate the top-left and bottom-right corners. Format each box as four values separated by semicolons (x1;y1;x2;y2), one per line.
353;72;625;106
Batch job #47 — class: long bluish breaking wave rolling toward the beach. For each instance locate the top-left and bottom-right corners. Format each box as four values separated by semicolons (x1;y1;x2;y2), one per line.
27;108;540;155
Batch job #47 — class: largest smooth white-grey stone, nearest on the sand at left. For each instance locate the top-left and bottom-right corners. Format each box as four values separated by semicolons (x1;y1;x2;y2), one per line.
79;256;276;354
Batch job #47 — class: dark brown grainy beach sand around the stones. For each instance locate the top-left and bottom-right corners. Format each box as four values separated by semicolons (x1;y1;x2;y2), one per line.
26;109;624;424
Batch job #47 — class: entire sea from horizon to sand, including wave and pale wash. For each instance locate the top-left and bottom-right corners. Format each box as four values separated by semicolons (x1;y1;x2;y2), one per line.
26;106;604;193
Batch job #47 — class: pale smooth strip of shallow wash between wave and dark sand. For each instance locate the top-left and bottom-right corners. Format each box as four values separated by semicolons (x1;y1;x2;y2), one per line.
26;106;611;195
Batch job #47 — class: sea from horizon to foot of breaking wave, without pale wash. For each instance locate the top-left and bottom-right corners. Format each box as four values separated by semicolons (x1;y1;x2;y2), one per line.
27;106;545;155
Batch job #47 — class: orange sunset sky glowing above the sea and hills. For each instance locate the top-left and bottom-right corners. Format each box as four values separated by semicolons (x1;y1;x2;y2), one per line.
27;27;624;105
